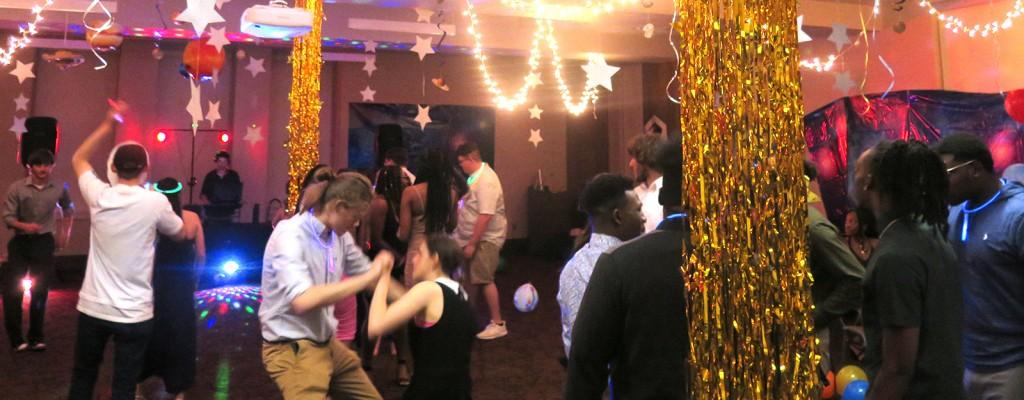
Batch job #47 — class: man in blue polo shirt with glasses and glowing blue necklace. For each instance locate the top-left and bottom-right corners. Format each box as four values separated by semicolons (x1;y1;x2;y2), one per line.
936;134;1024;400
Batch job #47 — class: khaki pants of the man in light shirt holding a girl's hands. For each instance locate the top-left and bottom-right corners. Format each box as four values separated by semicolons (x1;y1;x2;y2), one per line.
263;339;381;400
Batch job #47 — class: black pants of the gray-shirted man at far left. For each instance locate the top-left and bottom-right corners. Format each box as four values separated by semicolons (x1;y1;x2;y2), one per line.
0;233;54;347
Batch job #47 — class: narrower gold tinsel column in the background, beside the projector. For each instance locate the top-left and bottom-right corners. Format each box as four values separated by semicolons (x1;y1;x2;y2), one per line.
285;0;324;210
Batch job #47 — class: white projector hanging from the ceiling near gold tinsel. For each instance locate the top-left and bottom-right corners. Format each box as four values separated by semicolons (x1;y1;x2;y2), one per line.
242;0;313;39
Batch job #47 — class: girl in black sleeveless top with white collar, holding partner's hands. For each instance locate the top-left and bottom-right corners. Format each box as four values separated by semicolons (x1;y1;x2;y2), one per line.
368;234;478;400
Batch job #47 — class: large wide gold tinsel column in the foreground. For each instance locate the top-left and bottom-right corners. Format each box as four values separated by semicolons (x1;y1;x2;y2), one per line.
676;0;816;400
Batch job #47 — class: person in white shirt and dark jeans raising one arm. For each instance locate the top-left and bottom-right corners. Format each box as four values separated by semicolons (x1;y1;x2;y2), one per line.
69;102;183;400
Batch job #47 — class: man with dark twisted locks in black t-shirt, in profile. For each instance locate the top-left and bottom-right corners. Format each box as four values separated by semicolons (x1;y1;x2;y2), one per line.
853;141;964;400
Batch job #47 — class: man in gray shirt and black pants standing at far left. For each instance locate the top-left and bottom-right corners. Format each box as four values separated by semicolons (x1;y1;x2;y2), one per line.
0;149;75;352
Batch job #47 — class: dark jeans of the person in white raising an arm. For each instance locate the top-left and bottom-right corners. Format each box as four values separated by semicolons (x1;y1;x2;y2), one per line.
68;313;153;400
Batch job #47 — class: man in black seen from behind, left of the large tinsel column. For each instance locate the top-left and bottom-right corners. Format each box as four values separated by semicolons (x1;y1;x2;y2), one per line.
565;143;689;400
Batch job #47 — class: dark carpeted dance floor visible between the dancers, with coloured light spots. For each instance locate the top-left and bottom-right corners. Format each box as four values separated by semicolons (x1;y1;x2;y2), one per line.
0;256;565;400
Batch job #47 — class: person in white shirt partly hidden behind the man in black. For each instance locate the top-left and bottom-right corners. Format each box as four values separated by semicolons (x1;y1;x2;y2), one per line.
626;134;665;232
